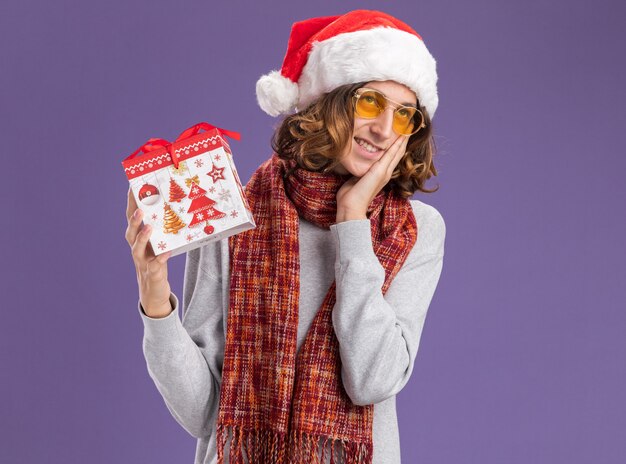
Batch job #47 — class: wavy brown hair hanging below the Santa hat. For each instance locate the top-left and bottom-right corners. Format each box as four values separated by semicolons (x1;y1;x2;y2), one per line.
272;82;439;198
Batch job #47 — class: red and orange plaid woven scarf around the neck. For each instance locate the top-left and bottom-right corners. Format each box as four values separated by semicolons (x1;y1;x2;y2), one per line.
217;155;417;464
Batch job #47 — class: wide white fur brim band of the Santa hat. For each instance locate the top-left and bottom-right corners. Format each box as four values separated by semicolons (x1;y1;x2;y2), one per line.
296;27;439;118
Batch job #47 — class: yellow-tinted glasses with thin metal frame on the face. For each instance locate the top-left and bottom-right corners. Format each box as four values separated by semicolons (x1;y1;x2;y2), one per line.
354;87;426;135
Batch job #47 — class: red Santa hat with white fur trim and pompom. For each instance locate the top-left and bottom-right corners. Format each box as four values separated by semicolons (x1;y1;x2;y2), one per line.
256;10;439;118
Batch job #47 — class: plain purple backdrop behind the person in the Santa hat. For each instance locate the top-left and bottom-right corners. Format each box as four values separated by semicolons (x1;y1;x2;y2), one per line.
0;0;626;464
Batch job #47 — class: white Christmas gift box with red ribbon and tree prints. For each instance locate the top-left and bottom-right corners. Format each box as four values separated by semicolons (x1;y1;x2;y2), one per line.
122;123;255;256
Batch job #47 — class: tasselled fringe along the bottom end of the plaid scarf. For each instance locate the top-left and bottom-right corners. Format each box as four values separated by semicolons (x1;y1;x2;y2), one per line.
217;424;374;464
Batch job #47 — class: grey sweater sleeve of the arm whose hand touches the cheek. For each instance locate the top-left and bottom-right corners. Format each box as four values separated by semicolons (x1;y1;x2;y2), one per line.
331;205;445;405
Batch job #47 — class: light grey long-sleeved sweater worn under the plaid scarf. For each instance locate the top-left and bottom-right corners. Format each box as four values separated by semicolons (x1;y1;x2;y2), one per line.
139;200;445;464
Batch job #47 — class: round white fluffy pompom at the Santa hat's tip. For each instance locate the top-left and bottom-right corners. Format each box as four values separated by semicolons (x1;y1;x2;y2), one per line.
256;71;298;116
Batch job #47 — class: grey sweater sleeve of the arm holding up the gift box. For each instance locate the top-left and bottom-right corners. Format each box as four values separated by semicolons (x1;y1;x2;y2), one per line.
139;241;224;438
